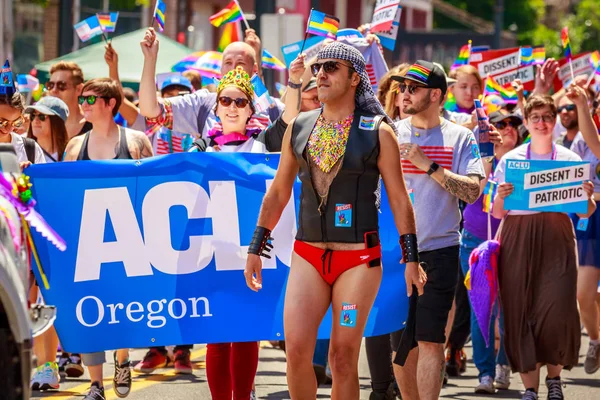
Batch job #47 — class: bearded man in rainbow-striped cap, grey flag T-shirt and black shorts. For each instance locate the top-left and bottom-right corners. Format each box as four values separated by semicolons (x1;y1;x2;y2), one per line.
392;60;497;400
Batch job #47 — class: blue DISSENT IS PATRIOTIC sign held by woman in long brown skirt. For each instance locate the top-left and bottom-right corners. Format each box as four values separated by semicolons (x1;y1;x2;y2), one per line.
504;160;590;214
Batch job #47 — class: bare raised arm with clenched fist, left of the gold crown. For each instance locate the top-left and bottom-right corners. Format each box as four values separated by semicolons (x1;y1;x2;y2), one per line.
140;28;161;118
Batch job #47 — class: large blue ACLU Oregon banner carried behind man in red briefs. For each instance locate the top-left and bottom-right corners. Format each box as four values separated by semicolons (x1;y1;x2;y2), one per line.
27;153;408;353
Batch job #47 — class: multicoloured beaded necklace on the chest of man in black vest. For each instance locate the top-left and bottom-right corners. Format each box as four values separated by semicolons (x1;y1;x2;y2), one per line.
308;114;354;173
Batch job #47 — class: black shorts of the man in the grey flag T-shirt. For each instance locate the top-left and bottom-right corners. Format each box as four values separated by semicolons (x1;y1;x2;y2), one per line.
392;246;460;365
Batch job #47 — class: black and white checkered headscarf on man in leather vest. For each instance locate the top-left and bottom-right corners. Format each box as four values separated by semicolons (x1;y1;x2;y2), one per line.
317;42;398;135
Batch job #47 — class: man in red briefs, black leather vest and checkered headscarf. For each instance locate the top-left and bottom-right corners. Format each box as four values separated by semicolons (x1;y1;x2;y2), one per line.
244;42;426;400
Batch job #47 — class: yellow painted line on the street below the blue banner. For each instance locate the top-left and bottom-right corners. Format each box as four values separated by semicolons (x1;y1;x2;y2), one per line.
39;347;206;400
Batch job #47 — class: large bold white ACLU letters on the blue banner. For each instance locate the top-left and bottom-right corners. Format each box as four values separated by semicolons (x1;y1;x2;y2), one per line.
75;180;296;282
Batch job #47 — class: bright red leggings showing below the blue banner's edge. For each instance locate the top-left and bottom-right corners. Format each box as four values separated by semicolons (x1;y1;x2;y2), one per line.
206;342;258;400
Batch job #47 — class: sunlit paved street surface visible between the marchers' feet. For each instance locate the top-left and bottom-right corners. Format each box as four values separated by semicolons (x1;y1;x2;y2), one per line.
32;337;600;400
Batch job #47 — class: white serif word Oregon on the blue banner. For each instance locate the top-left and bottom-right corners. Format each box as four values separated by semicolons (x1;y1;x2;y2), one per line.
75;296;212;328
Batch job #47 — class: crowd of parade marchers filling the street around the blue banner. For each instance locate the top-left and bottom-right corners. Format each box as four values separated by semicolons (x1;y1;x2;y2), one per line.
0;10;600;400
